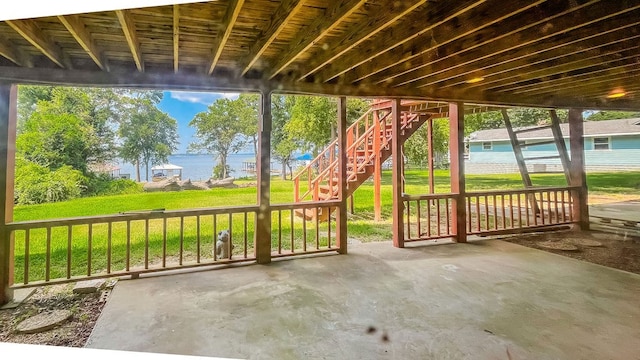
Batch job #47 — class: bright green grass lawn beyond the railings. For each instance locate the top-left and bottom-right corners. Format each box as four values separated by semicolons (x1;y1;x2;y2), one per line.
14;170;640;283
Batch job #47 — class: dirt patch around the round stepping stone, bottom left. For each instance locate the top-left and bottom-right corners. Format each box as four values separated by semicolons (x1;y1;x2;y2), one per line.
0;284;105;347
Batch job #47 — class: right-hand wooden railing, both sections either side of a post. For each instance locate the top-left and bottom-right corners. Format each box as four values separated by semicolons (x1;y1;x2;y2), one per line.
403;186;579;242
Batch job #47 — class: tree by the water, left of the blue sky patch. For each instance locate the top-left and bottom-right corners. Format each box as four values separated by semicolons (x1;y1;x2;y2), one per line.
120;98;178;181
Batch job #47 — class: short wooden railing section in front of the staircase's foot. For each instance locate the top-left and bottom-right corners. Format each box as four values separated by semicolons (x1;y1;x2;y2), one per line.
271;200;340;258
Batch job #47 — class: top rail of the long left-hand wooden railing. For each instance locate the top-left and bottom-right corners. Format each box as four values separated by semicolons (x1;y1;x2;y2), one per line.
7;205;259;230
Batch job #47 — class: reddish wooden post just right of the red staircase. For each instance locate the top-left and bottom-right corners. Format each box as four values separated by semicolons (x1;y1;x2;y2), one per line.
391;99;404;248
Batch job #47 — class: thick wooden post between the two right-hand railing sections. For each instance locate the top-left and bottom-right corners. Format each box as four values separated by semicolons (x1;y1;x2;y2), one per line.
449;103;467;242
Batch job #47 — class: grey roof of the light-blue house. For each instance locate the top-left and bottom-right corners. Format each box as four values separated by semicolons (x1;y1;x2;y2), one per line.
468;118;640;142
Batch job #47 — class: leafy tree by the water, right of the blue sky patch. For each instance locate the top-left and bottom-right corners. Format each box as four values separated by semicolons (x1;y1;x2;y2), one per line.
189;98;245;178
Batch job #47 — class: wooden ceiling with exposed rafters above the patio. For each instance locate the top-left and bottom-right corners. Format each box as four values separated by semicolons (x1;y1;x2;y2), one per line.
0;0;640;110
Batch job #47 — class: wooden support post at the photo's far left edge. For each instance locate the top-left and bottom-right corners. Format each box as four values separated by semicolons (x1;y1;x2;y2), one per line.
0;85;18;305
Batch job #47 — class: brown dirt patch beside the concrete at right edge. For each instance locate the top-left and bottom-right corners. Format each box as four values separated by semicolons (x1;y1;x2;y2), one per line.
503;231;640;274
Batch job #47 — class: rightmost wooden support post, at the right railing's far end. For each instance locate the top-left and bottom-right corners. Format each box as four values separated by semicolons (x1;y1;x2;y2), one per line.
569;109;589;230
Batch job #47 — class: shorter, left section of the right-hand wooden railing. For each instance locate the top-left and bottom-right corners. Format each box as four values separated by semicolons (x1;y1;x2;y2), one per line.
403;194;456;242
